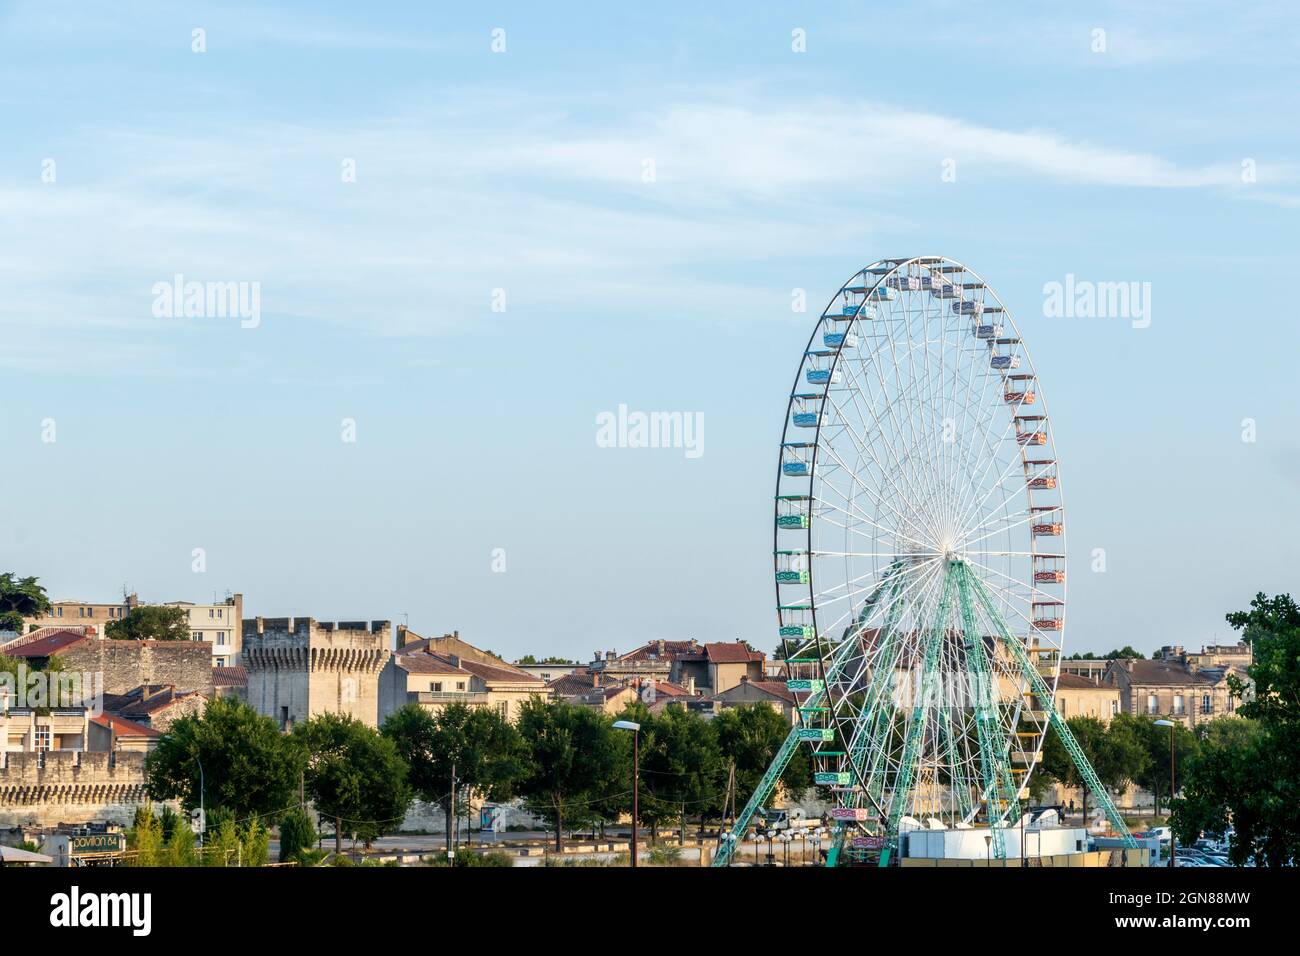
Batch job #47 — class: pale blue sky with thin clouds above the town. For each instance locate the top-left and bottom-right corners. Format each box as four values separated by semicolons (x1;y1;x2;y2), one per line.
0;3;1300;658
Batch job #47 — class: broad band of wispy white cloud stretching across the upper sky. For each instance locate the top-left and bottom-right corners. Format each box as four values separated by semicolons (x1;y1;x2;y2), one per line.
0;93;1294;369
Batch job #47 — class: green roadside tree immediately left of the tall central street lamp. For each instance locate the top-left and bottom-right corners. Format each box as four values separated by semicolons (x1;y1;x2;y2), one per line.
517;697;631;851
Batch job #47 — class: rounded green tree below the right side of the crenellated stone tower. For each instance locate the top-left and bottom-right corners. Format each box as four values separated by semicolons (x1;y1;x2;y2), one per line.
293;714;411;853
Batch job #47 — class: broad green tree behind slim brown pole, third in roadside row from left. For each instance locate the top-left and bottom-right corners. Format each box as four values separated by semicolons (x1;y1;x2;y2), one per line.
382;702;528;849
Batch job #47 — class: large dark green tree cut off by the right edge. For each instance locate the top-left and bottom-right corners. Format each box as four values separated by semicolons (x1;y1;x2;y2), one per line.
1170;593;1300;866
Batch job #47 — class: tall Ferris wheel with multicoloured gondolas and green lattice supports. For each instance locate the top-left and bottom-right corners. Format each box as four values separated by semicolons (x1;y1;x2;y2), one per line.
714;256;1136;866
